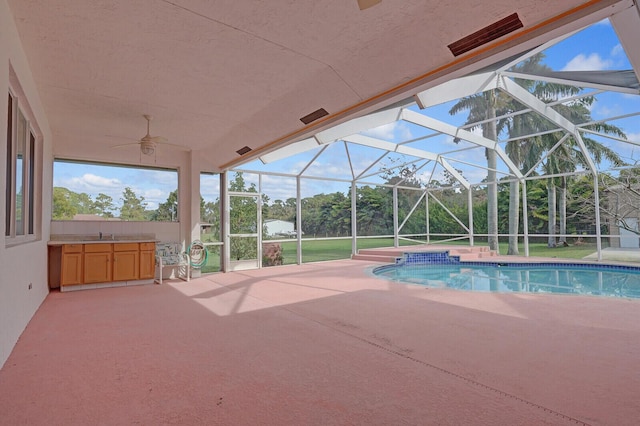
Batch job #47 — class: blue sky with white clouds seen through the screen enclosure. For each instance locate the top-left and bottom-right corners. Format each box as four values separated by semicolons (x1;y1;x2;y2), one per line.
53;20;640;209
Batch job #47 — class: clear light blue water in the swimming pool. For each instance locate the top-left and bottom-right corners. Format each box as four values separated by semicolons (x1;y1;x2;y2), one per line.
373;262;640;298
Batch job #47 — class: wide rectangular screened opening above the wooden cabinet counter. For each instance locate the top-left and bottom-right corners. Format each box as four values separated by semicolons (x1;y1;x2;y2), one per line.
52;159;179;222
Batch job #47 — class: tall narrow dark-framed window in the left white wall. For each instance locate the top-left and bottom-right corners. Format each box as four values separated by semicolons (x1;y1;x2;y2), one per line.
5;92;39;243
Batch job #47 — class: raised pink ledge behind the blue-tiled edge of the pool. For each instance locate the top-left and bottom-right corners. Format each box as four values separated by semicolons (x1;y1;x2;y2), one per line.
351;245;496;263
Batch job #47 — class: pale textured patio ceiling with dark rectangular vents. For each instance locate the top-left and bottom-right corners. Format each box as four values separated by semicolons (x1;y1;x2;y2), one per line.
8;0;615;169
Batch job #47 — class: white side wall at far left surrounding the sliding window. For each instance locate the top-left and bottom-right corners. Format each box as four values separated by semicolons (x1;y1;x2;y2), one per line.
0;0;52;366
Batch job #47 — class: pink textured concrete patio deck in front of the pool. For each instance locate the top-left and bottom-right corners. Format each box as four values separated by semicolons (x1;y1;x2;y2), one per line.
0;260;640;425
